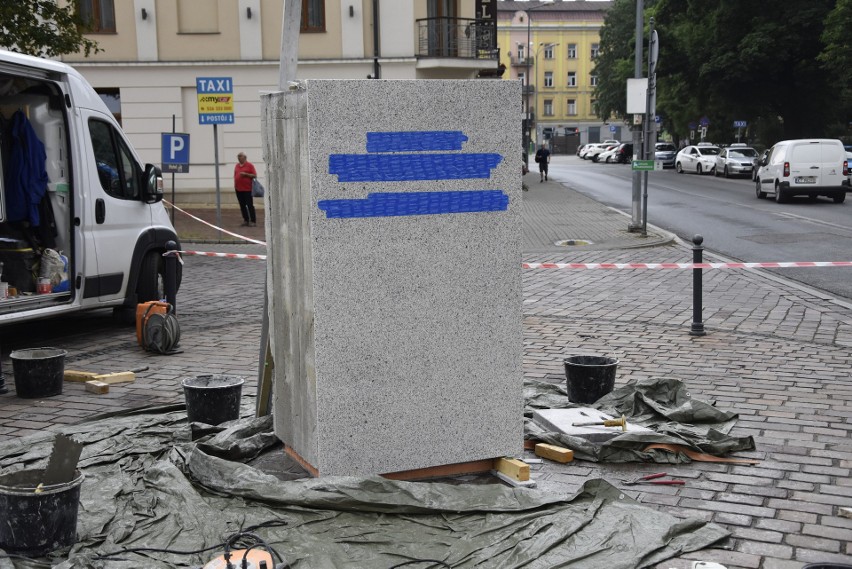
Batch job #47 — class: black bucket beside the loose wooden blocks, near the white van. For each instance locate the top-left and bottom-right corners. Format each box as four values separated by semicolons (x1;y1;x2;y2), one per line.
9;348;68;399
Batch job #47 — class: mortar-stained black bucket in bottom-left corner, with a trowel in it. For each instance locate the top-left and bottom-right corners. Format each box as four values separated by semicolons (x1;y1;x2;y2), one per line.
0;470;83;557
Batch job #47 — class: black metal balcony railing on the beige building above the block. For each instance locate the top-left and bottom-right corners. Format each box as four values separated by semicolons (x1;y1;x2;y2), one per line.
417;18;498;60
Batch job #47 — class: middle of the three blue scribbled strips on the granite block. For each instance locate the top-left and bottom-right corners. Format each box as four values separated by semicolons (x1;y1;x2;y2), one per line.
328;154;503;182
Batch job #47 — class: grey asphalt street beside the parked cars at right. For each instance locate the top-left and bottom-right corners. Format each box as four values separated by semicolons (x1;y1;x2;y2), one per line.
550;155;852;300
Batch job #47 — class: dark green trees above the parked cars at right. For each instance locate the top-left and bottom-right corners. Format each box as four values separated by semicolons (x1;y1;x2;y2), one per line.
596;0;852;144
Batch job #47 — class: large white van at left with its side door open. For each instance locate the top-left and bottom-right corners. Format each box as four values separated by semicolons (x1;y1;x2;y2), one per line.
0;50;179;325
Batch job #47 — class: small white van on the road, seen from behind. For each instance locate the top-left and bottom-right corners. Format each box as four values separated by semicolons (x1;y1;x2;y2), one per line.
755;138;850;203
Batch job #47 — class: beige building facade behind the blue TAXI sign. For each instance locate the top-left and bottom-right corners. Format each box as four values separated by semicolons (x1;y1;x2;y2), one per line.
62;0;498;203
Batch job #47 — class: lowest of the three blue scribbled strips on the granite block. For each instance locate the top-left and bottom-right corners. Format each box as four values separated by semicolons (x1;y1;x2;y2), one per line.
317;190;509;219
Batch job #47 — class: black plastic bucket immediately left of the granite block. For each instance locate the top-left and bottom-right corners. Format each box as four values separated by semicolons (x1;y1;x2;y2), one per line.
181;375;245;425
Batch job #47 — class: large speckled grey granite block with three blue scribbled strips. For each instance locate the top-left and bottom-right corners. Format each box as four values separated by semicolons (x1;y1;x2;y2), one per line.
263;80;523;476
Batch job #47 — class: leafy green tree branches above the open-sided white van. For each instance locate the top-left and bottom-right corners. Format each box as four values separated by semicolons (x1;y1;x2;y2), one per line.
0;0;100;57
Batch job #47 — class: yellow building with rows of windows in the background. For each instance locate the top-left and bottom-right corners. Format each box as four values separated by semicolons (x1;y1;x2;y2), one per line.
497;0;616;150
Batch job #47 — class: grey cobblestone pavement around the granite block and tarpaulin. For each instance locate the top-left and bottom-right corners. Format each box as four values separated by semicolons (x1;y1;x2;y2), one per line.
0;156;852;569
